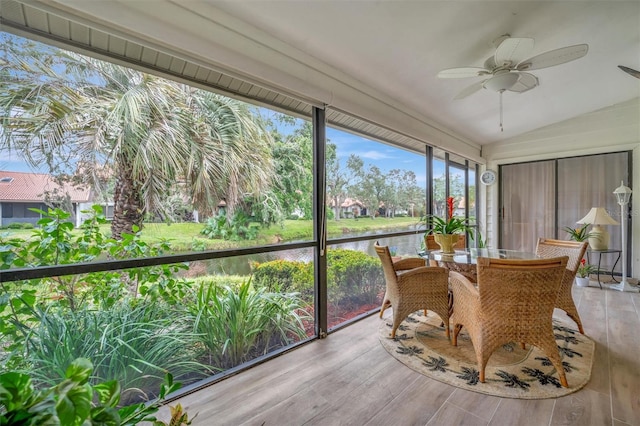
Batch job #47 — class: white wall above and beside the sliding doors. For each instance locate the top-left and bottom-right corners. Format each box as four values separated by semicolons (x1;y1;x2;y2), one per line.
480;98;640;277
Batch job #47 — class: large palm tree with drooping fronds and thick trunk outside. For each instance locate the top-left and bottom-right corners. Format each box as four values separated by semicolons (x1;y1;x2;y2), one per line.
0;35;273;238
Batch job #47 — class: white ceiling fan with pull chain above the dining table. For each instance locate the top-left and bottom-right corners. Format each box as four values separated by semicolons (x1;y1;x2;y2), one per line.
438;34;589;130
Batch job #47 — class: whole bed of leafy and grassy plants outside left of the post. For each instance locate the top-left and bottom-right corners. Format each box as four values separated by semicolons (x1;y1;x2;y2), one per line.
0;209;306;403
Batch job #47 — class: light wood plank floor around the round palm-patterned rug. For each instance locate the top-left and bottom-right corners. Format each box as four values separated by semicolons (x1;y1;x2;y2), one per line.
156;283;640;426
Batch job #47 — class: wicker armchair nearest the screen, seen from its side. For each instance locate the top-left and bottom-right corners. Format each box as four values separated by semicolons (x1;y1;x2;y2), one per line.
375;243;449;338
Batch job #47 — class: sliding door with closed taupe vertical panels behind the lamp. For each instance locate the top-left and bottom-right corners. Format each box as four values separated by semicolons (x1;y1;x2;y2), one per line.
500;152;631;271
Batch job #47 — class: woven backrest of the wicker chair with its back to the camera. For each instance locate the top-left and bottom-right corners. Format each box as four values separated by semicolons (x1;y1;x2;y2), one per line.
477;256;569;318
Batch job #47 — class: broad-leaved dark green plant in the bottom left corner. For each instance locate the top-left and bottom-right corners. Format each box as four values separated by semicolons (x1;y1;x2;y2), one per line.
0;358;190;426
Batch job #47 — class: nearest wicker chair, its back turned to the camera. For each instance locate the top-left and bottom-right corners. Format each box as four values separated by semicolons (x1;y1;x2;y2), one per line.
449;256;568;387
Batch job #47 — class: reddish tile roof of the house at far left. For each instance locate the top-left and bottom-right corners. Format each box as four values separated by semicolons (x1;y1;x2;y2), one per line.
0;170;91;202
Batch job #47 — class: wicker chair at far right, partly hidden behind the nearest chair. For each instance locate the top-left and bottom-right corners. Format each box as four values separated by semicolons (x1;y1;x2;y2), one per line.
536;238;589;334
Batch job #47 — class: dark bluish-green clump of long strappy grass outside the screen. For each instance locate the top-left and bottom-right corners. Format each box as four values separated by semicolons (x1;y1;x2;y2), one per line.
25;300;210;404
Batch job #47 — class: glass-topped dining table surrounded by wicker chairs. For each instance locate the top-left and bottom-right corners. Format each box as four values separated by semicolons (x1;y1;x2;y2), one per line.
420;248;538;283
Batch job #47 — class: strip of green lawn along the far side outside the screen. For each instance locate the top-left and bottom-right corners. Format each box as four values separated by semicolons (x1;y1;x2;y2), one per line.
0;217;418;251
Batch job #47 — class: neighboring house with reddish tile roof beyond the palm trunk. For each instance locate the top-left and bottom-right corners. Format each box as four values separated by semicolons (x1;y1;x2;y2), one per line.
0;171;92;226
